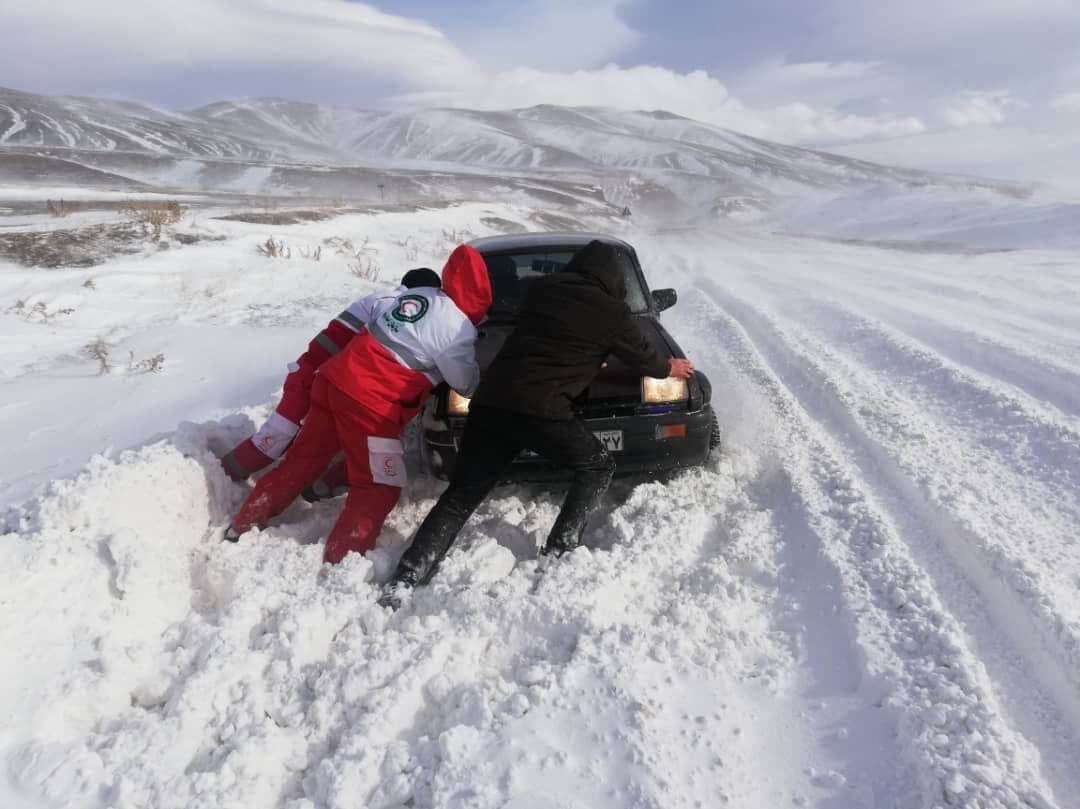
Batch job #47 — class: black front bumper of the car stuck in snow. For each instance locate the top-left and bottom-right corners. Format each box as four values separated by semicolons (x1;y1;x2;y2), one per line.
424;405;713;482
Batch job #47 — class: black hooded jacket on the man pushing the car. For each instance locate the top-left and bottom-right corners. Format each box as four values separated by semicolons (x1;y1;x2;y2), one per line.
473;241;670;419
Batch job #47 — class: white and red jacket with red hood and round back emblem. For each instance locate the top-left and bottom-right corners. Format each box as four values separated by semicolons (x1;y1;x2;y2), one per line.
316;245;491;428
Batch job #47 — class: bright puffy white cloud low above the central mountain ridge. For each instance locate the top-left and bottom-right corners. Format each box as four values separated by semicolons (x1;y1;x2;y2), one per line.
401;65;926;144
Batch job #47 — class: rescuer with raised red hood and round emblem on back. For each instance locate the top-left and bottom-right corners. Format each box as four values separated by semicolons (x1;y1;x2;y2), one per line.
225;245;491;563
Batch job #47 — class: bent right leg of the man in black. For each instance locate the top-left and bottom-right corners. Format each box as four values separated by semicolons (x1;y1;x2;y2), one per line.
518;419;615;556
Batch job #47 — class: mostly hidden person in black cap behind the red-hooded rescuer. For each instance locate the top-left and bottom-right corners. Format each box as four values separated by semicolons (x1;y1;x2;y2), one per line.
221;267;442;479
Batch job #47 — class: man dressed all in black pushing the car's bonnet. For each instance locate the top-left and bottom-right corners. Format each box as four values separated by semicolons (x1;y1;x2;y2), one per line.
380;241;693;607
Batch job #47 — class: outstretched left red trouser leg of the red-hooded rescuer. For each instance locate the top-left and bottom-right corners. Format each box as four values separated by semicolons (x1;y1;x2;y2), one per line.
229;378;340;538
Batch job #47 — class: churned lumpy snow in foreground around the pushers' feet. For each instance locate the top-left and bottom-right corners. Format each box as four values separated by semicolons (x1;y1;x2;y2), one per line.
0;410;885;809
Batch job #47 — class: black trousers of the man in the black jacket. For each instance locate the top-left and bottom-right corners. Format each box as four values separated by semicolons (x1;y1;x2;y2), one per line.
393;405;615;586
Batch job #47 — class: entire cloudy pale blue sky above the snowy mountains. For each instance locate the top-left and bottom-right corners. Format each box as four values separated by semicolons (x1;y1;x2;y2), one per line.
0;0;1080;180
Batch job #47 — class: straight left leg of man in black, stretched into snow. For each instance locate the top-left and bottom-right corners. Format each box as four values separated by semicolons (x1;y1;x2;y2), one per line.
390;407;521;588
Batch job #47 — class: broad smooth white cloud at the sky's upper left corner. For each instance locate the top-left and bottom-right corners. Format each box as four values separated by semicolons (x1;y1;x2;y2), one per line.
0;0;473;86
